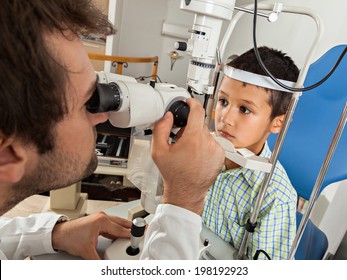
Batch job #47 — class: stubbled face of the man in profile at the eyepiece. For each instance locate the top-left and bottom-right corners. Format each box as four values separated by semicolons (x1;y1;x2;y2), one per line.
12;32;107;202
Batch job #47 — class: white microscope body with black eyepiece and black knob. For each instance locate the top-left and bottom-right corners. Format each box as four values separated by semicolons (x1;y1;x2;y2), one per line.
86;82;189;127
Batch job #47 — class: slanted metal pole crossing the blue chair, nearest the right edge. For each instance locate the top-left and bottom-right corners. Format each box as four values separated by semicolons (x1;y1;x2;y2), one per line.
288;103;347;260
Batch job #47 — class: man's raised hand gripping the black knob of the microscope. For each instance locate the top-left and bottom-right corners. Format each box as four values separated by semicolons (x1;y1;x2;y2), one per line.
152;99;225;215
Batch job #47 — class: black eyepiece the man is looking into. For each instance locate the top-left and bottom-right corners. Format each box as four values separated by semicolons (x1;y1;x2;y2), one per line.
86;83;122;114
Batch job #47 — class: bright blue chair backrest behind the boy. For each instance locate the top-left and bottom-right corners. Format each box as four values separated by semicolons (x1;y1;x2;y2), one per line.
268;45;347;199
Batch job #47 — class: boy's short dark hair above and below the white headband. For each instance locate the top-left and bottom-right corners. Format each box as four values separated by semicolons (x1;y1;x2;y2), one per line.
228;47;299;120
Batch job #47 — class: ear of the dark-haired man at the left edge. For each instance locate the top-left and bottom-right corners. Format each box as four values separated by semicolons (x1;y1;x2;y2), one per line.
0;137;28;184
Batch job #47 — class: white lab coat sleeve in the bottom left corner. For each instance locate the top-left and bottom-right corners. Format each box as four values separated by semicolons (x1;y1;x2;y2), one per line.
0;213;62;260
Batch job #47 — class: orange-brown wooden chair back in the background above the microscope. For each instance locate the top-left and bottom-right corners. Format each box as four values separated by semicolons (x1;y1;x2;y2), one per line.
88;53;159;80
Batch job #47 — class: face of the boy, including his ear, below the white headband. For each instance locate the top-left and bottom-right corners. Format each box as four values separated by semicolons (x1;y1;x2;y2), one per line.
215;76;283;154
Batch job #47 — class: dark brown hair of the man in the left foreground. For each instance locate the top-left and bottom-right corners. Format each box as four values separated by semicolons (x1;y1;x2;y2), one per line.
0;0;114;153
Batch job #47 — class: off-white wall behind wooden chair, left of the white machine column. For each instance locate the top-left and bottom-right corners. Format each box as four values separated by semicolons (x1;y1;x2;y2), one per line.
106;0;193;86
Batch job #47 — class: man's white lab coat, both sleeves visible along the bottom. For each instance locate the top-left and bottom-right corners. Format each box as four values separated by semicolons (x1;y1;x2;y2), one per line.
0;204;202;260
